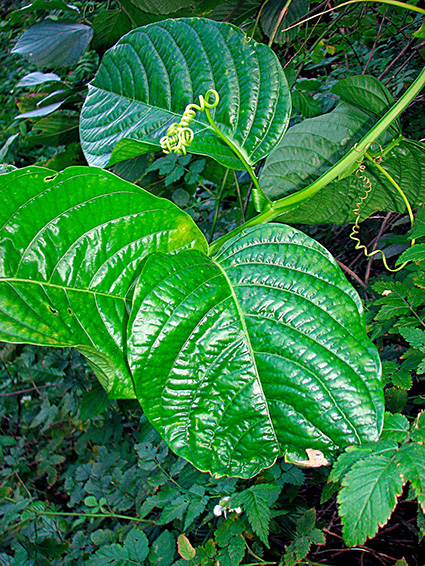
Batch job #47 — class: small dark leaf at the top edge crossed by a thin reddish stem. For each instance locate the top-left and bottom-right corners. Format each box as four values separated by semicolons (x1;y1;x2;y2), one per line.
260;0;310;44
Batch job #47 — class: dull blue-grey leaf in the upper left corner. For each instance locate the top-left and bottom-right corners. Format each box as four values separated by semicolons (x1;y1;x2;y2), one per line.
12;20;93;67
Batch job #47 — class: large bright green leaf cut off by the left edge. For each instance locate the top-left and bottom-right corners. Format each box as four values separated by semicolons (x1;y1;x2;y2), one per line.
0;167;206;397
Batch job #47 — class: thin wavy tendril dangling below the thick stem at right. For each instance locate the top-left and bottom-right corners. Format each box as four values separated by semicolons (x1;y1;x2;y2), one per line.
350;142;415;273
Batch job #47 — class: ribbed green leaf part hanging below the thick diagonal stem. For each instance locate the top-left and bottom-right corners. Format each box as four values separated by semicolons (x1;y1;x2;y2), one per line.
272;140;425;224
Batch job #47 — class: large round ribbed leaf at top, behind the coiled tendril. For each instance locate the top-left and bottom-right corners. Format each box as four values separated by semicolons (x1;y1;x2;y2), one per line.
80;18;291;169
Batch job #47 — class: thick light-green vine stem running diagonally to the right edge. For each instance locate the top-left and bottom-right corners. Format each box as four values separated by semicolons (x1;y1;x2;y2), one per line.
209;68;425;255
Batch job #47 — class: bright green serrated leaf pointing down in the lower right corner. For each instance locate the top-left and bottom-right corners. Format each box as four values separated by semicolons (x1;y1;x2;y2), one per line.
338;454;404;546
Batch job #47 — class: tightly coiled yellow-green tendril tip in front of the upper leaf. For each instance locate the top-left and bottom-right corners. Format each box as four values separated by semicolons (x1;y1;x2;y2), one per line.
159;89;220;155
